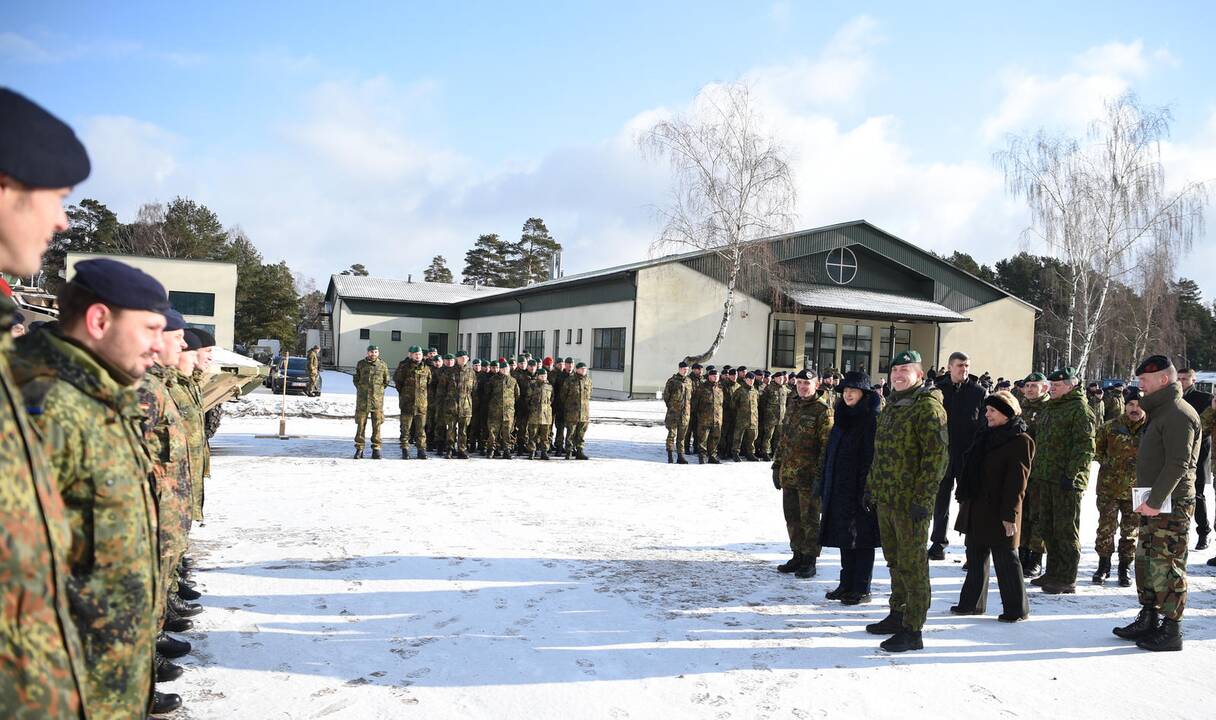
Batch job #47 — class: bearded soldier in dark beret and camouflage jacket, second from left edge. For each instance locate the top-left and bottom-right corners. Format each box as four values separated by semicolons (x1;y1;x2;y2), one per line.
10;259;171;718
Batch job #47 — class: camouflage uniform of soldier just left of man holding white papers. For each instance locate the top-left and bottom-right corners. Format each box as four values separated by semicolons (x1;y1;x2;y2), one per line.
1093;415;1144;562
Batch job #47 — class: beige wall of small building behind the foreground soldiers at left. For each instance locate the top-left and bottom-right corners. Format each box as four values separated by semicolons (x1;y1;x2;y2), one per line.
64;253;236;350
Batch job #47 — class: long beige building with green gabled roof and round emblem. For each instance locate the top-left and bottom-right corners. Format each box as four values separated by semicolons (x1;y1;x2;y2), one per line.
322;220;1038;398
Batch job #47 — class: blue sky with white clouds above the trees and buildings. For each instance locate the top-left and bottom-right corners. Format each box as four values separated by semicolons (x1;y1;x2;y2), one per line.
0;2;1216;299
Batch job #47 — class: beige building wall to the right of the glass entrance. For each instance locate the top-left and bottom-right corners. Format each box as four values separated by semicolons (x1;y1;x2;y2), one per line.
938;298;1035;379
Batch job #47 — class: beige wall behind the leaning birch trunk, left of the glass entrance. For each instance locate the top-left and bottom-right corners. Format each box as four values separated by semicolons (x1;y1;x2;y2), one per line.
634;263;770;395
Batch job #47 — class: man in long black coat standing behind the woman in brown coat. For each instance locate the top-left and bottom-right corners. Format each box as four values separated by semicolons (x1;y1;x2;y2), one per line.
929;351;987;559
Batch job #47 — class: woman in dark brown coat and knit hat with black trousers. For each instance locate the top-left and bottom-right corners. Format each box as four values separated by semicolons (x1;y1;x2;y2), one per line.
950;390;1035;623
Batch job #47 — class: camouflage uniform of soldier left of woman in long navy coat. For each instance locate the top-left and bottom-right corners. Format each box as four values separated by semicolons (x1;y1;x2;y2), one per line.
772;398;832;559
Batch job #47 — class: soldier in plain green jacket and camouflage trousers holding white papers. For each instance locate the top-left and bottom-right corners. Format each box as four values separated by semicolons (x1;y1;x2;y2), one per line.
1114;355;1201;652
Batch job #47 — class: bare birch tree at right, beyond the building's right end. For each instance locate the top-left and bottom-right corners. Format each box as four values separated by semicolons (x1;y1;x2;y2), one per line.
996;94;1206;370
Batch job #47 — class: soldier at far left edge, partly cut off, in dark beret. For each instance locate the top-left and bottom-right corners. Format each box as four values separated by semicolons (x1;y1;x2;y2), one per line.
0;89;89;719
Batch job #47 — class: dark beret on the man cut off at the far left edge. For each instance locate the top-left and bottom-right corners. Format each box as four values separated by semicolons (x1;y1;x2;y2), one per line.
0;88;89;187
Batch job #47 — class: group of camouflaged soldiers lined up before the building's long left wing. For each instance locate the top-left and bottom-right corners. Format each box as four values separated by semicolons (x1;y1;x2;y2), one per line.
355;345;592;460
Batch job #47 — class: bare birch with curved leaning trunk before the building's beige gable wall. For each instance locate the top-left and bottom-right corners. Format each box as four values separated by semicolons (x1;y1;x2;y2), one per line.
638;83;796;362
